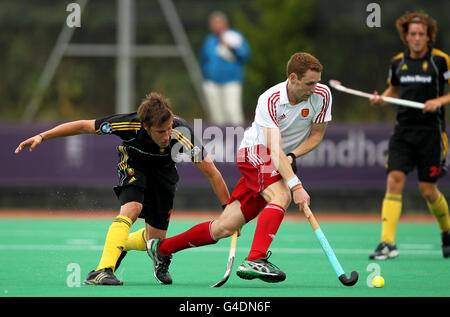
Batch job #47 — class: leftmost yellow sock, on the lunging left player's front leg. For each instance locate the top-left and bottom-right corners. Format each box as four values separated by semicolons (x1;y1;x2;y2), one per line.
97;216;133;271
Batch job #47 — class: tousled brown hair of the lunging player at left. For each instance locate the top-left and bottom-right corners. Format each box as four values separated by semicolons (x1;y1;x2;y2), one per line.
137;92;173;127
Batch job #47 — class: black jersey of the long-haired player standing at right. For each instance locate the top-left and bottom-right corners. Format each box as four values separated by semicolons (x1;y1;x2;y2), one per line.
388;47;450;130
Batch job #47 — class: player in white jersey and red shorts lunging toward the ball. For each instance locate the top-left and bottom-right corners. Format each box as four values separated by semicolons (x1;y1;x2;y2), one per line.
147;52;332;282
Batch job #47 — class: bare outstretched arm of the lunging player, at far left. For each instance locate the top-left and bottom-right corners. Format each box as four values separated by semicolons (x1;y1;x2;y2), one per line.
14;120;95;154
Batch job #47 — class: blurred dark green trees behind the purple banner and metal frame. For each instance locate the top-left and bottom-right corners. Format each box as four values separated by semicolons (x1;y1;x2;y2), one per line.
0;0;450;122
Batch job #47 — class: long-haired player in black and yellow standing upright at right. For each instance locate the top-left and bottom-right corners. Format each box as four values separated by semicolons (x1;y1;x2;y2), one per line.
369;13;450;260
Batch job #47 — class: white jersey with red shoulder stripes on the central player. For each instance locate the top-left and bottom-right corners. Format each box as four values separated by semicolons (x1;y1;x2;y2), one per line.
240;80;332;153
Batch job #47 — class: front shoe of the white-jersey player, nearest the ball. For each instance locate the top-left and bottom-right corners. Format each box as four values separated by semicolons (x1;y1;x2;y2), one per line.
236;251;286;283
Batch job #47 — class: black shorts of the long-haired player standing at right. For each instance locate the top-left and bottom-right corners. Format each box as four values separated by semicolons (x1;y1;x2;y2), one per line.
387;127;448;183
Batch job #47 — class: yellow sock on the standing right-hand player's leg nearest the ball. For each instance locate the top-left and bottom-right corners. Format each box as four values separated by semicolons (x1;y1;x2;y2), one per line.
381;194;402;244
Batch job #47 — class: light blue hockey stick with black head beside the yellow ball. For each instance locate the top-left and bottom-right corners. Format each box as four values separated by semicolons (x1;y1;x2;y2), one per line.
303;204;358;286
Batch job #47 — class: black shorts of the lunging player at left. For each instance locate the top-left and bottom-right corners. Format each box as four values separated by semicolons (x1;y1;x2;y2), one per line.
114;167;176;230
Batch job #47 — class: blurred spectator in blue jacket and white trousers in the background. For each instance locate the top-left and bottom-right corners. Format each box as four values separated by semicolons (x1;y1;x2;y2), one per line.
200;11;250;125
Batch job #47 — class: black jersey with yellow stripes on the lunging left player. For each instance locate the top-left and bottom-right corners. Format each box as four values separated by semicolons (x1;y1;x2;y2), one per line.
95;112;207;168
